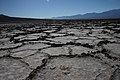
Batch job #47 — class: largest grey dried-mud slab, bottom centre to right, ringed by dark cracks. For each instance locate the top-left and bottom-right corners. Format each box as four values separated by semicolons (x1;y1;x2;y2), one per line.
34;57;113;80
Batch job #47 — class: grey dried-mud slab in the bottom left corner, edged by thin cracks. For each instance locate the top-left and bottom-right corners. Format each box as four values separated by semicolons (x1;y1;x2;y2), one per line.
0;57;32;80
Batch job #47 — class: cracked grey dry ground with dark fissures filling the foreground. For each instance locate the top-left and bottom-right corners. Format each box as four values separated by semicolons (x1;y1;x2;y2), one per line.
0;24;120;80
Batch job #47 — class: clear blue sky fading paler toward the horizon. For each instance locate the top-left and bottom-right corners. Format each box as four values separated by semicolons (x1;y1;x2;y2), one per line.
0;0;120;18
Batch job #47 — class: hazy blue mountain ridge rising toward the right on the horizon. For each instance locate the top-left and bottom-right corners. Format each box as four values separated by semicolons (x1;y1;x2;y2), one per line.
53;9;120;19
